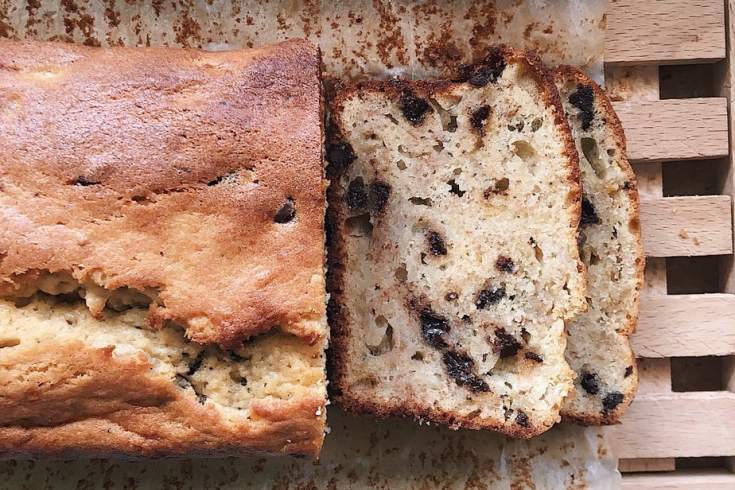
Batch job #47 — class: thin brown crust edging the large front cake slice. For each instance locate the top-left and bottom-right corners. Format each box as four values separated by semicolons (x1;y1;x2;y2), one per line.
327;46;586;438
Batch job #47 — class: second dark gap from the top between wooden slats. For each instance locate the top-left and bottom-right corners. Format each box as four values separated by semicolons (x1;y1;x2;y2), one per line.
662;158;729;197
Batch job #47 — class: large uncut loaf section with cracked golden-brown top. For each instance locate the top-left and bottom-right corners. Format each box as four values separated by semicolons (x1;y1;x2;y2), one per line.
0;40;328;456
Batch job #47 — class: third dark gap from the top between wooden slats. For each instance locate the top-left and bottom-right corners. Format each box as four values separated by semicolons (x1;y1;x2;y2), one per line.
666;255;723;294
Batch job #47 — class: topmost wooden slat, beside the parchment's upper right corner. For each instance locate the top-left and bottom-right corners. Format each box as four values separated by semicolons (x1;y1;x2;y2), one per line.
605;0;725;64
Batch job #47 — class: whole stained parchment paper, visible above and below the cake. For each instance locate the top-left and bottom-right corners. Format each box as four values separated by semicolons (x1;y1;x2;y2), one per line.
0;0;621;490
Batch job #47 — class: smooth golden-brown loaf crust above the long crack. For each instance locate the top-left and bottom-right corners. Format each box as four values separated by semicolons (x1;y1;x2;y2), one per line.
0;40;326;345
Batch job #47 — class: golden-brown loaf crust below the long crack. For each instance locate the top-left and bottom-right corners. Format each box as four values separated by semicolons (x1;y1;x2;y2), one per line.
0;341;324;457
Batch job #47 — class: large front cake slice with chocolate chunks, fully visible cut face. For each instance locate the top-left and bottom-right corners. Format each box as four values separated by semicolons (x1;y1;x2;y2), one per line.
327;48;586;437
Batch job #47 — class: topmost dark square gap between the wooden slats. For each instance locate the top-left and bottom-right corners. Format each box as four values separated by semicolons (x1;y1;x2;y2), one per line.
658;64;716;99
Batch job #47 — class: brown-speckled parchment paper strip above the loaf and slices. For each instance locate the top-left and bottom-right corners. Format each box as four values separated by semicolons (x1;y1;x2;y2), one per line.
0;0;607;79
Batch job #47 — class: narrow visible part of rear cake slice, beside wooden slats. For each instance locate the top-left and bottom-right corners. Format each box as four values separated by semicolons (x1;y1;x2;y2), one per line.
554;67;645;424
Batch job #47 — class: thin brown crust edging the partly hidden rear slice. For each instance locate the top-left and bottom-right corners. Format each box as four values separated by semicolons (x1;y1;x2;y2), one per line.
553;65;645;425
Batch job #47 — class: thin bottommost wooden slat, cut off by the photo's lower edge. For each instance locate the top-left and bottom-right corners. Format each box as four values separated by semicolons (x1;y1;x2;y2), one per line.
623;470;735;490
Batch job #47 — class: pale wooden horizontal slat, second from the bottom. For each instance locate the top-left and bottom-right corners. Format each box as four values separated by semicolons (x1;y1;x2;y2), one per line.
607;391;735;458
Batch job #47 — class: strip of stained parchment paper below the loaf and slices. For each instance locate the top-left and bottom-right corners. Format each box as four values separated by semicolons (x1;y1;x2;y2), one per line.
0;409;620;490
